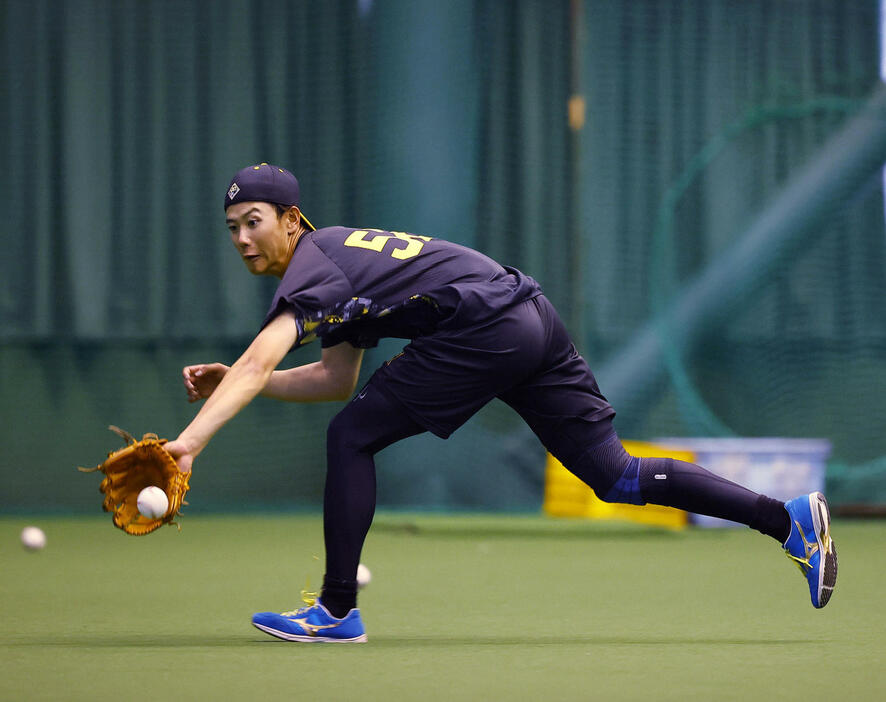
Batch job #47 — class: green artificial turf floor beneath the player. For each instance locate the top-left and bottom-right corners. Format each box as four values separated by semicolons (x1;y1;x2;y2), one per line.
0;515;886;702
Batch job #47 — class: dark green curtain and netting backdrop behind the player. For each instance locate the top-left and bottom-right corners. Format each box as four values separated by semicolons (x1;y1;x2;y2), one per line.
0;0;886;509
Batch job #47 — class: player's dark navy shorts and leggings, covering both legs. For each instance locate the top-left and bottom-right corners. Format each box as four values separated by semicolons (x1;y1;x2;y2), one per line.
324;296;787;592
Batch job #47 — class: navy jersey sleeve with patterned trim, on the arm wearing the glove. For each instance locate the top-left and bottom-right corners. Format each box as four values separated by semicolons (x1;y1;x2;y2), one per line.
262;238;354;346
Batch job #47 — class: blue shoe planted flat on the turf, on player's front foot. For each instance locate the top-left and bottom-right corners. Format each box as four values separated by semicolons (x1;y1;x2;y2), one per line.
252;600;367;643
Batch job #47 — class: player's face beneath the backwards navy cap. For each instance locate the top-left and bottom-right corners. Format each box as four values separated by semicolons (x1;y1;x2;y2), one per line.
225;202;292;278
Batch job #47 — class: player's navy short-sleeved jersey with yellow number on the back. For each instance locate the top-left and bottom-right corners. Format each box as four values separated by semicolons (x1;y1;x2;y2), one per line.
263;227;541;348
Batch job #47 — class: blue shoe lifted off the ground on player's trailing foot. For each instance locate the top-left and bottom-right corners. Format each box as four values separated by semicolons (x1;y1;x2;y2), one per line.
784;492;837;607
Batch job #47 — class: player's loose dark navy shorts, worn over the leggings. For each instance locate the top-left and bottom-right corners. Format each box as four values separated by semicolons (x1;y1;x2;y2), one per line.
369;295;615;456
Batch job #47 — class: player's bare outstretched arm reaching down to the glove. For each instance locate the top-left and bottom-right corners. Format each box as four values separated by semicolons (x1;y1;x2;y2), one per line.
166;312;298;471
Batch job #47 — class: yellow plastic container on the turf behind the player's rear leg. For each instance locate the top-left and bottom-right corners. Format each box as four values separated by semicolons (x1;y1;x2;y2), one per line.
543;441;695;529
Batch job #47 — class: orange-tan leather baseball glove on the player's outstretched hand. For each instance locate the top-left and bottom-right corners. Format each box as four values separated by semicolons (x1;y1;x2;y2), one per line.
78;426;191;536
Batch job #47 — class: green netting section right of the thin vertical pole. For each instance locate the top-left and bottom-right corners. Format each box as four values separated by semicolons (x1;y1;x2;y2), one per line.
583;1;886;502
